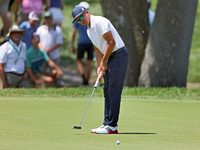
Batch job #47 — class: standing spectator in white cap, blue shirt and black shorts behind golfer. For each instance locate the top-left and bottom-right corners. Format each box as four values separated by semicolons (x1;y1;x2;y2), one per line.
72;2;94;85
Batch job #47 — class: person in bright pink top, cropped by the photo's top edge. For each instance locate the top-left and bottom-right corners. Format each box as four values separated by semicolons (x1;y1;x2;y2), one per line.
15;0;45;25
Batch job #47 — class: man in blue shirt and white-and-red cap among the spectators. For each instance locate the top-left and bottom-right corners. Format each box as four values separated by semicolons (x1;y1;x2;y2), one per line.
20;11;39;49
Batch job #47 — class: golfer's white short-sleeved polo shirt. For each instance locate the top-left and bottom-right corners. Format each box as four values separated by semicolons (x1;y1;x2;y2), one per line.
87;15;125;54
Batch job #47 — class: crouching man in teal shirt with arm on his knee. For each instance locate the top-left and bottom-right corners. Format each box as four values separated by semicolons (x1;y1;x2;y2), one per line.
26;33;63;84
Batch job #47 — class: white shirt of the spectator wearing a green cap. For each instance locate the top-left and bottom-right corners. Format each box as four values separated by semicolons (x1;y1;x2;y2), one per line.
36;25;63;60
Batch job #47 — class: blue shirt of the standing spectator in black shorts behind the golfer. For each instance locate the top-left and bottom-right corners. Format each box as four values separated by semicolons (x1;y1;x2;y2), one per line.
73;22;92;44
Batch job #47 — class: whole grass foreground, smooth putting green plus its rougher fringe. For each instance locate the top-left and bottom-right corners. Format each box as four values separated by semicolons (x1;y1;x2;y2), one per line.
0;88;200;150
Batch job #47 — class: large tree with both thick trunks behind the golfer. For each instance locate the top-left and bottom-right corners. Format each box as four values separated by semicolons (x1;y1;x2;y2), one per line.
101;0;198;87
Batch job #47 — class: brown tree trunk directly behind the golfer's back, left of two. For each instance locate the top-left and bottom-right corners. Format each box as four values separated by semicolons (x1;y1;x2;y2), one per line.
100;0;148;86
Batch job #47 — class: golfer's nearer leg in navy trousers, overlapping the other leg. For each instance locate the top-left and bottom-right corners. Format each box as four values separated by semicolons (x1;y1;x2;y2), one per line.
108;51;128;127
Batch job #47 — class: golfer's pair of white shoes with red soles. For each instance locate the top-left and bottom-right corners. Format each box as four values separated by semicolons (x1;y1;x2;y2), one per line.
93;125;118;134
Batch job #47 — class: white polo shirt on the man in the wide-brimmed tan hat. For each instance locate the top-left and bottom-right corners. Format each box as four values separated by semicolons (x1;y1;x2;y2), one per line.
0;39;26;74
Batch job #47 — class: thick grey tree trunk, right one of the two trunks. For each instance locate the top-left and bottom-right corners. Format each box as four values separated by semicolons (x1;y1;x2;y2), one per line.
139;0;198;87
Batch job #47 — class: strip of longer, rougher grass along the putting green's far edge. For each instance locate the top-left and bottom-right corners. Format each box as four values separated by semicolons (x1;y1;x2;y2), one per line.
0;87;200;101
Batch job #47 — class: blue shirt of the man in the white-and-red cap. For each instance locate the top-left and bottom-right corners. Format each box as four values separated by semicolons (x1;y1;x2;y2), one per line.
20;21;39;49
